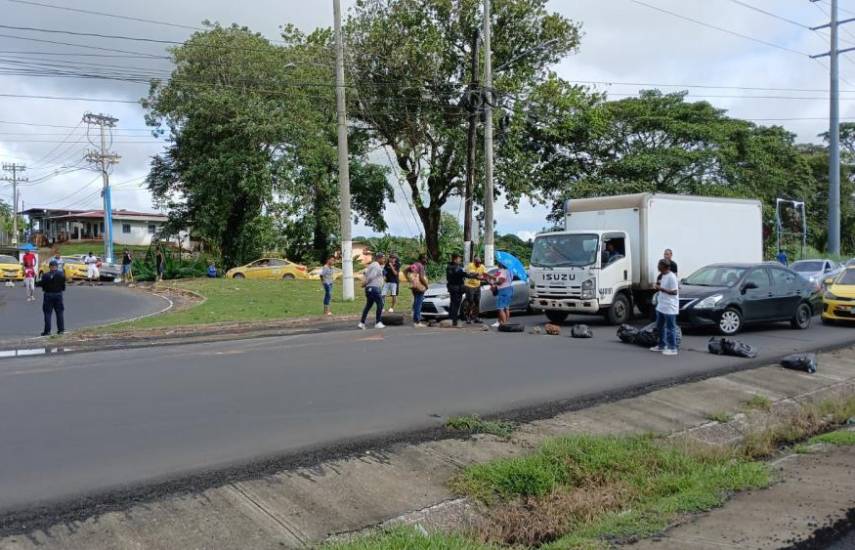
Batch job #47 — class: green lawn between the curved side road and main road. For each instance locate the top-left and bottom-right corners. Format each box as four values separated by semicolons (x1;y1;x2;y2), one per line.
111;279;412;329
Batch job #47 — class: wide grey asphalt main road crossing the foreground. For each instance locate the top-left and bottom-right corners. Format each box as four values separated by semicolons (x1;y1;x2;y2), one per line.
0;316;855;516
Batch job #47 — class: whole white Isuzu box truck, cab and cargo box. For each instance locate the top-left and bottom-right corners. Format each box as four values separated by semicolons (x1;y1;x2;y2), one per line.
529;193;763;324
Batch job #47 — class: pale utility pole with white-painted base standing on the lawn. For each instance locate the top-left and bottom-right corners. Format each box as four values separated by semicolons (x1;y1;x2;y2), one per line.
333;0;355;301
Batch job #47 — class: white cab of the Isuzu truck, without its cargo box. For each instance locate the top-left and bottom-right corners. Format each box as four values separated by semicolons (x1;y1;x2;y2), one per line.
529;230;633;324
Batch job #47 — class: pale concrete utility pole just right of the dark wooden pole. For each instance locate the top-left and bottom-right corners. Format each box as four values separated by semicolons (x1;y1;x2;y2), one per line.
484;0;496;268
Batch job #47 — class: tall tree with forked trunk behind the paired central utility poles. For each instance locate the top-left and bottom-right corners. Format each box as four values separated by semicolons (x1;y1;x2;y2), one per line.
347;0;579;260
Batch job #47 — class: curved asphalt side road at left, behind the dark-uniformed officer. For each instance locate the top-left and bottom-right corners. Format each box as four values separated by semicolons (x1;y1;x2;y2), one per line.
0;283;169;340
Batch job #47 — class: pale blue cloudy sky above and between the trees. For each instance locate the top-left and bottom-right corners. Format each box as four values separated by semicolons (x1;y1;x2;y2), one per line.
0;0;855;242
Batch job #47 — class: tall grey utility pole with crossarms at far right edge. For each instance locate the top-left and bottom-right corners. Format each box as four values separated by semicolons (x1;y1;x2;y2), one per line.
811;0;855;254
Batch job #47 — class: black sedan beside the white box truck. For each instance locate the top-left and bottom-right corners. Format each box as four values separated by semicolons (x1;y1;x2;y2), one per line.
678;263;820;336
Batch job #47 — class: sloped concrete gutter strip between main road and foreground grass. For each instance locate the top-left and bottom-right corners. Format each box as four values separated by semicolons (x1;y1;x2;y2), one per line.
0;349;855;550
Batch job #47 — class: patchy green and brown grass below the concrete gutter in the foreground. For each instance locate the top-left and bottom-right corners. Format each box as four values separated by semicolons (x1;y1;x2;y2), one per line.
323;397;855;550
